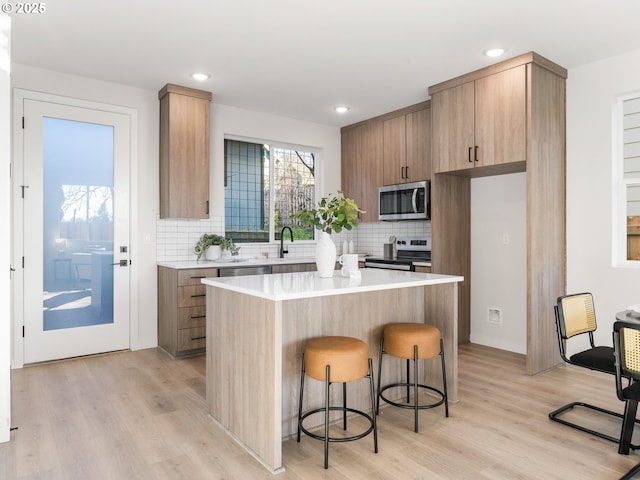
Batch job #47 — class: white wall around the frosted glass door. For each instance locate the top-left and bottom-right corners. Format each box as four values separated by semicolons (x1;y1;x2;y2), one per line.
11;64;162;360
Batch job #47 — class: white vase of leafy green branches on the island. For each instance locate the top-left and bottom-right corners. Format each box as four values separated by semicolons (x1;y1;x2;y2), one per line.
292;190;365;278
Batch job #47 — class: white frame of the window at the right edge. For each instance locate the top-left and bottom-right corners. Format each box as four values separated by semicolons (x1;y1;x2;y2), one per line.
612;90;640;268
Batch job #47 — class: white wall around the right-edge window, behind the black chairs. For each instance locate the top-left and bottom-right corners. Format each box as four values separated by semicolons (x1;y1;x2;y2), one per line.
564;50;640;345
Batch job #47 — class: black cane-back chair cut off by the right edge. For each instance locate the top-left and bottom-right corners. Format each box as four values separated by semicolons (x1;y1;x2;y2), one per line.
613;322;640;455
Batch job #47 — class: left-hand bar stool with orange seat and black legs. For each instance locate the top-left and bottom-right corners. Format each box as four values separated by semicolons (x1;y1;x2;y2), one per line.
297;336;378;469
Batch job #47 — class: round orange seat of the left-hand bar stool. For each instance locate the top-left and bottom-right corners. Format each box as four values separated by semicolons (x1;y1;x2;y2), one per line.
304;337;369;383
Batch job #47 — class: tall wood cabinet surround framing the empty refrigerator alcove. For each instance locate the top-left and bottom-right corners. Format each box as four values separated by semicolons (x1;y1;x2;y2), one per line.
429;52;567;375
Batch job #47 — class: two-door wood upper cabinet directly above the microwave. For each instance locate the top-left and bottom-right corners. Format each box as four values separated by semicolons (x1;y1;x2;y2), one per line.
383;102;431;185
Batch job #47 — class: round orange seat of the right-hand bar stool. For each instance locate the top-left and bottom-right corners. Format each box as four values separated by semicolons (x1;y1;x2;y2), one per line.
383;323;440;360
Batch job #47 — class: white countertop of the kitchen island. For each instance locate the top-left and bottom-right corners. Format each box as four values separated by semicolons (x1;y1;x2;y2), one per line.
202;268;464;301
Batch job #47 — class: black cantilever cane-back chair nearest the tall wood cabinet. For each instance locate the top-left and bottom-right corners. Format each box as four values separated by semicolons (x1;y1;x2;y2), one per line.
549;293;636;450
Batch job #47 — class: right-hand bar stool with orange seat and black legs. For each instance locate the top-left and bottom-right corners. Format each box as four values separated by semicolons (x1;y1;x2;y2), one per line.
376;323;449;433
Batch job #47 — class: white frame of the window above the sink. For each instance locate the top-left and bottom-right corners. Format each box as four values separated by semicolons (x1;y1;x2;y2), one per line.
223;134;324;245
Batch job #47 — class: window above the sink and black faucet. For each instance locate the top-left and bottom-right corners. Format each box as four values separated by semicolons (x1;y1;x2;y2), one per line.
224;139;316;243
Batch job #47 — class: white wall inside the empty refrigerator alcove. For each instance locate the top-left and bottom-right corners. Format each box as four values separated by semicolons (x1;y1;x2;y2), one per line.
470;173;527;354
